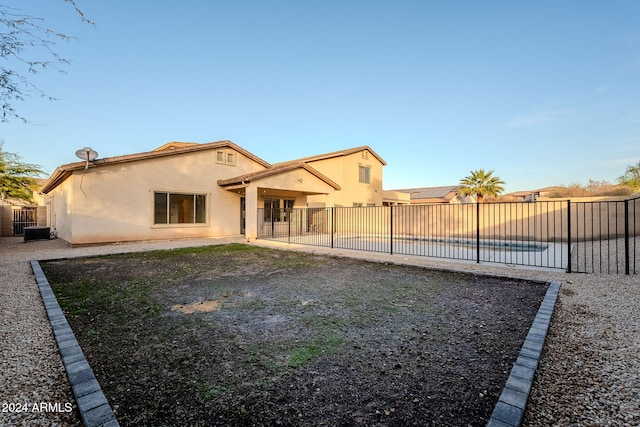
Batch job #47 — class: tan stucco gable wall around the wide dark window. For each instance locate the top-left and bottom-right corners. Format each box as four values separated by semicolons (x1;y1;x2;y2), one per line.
49;150;264;244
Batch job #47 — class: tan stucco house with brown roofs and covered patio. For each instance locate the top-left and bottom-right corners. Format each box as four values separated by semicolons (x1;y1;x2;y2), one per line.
42;141;386;245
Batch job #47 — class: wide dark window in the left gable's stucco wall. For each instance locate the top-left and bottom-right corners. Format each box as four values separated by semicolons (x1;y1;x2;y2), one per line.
153;192;207;224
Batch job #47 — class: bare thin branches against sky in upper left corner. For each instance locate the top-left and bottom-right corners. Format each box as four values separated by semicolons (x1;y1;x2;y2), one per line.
0;0;93;123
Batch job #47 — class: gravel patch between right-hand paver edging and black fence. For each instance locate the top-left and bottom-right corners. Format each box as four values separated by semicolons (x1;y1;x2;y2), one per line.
524;275;640;426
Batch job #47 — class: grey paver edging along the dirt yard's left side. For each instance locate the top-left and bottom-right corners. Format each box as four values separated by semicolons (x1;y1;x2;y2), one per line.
31;261;120;427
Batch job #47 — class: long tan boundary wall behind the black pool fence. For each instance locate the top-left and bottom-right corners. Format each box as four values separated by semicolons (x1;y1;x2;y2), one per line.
324;200;640;244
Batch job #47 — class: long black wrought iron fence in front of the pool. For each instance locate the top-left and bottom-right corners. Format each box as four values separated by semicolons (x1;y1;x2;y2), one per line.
258;198;640;274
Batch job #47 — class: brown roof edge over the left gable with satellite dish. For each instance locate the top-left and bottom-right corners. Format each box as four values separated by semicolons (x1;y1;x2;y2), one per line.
41;141;272;194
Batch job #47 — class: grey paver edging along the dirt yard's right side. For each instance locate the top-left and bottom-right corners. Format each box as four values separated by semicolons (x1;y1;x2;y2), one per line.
487;282;561;427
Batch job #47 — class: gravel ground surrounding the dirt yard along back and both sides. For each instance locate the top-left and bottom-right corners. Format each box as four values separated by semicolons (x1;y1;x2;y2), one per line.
0;237;640;427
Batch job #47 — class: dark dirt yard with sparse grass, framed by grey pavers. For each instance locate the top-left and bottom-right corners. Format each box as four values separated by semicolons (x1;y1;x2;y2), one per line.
42;244;546;426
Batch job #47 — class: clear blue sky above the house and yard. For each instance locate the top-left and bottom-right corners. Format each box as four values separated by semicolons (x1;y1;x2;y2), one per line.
0;0;640;192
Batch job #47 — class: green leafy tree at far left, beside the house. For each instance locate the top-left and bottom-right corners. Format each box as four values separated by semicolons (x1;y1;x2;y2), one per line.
0;141;45;202
